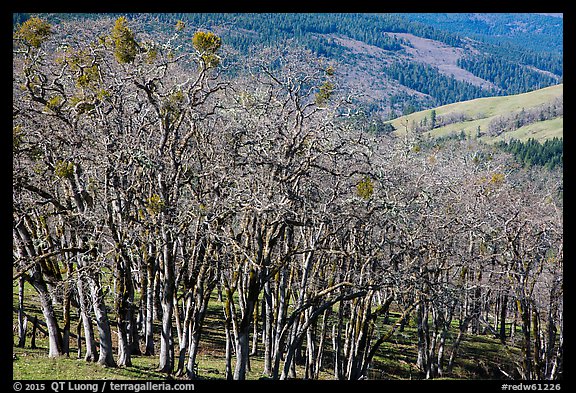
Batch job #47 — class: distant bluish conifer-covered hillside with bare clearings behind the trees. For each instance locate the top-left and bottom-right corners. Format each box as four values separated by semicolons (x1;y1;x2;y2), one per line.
13;13;563;119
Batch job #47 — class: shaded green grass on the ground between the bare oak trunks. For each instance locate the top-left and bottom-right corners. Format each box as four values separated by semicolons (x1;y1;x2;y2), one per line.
12;278;522;380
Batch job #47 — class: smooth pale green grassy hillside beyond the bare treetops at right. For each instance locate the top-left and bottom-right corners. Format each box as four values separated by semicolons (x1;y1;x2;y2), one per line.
389;84;564;143
